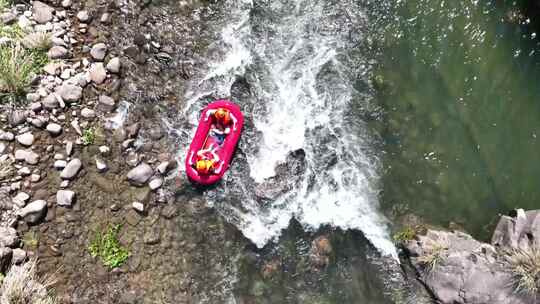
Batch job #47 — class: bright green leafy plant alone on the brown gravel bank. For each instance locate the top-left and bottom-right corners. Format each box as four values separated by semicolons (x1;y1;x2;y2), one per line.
88;225;129;268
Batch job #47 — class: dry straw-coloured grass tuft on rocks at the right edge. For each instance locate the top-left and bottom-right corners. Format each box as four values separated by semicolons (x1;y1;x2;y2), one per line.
505;248;540;298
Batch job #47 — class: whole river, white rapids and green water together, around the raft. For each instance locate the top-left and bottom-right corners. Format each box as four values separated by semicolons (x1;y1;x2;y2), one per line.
113;0;540;304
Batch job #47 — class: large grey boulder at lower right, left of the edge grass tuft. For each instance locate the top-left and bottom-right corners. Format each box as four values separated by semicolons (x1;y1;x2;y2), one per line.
404;230;535;304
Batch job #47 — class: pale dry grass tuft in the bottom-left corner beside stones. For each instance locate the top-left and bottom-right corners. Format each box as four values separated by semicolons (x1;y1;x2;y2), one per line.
0;259;56;304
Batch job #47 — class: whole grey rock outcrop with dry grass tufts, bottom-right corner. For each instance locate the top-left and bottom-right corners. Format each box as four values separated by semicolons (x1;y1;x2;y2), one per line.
402;209;540;304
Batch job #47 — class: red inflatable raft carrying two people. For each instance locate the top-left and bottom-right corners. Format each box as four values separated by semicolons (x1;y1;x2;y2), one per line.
186;100;244;185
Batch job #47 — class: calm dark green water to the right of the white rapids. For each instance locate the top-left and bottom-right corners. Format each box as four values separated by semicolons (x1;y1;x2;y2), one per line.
373;0;540;239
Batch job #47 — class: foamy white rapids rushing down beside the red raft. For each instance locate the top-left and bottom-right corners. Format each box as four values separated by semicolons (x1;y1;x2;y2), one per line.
181;0;397;257
